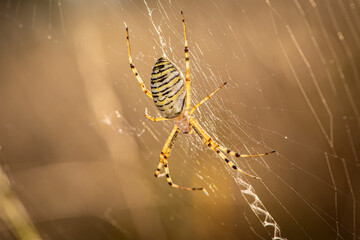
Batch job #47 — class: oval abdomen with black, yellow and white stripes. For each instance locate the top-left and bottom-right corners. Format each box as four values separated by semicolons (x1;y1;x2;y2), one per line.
151;57;186;118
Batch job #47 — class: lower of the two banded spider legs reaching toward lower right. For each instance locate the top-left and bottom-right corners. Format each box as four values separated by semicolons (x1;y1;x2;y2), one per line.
190;118;260;180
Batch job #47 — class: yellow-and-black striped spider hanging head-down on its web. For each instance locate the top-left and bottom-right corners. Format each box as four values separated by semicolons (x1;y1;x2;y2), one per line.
126;11;275;195
